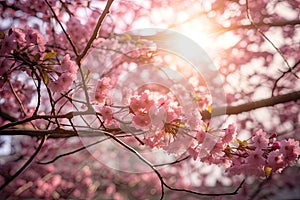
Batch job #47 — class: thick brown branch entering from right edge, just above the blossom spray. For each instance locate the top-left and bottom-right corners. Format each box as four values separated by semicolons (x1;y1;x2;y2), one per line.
201;91;300;119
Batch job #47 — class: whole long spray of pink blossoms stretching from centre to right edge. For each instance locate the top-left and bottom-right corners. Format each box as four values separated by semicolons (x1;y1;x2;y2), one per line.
95;77;300;177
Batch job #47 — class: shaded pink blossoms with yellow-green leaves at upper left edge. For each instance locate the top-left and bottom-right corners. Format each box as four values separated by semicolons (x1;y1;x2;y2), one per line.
0;27;78;92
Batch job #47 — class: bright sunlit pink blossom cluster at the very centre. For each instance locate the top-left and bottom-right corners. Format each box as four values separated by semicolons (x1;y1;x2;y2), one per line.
129;90;181;148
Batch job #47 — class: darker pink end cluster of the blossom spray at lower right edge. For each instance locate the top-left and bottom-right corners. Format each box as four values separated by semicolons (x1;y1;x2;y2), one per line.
224;130;300;176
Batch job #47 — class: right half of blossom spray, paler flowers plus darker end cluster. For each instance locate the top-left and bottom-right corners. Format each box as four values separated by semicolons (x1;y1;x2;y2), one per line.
188;124;300;177
